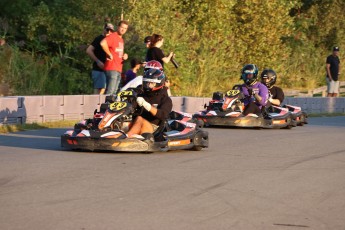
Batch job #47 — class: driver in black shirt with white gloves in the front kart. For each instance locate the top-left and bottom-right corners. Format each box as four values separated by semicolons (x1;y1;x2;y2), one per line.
123;68;172;137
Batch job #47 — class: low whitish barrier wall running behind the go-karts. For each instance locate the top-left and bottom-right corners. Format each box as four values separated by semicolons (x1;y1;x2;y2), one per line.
0;95;345;125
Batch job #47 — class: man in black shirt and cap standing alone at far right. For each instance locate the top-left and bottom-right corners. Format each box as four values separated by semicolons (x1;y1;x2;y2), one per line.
326;46;340;97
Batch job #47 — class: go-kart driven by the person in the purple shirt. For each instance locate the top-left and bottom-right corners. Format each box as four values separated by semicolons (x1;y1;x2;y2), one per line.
193;87;297;129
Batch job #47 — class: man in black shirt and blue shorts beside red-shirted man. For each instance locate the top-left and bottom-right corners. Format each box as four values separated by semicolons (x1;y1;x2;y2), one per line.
86;23;114;94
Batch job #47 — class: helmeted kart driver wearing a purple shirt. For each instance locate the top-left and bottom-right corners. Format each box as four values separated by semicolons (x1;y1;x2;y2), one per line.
240;64;269;116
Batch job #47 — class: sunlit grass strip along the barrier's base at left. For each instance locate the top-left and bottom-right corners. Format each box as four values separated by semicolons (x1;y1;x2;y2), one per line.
0;121;77;133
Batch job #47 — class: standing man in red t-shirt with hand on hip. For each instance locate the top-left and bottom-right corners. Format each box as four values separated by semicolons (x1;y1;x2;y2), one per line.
101;21;128;94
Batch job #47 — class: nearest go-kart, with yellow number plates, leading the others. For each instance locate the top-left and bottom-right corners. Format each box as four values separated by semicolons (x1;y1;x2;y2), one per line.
61;89;208;152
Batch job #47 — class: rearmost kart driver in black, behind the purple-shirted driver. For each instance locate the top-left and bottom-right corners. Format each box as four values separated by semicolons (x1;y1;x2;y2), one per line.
261;69;284;106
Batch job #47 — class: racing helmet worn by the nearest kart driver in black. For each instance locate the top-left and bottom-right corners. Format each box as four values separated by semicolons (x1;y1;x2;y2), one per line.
143;69;165;92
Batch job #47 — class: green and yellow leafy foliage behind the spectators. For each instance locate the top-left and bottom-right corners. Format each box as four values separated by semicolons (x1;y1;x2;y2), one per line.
0;0;345;96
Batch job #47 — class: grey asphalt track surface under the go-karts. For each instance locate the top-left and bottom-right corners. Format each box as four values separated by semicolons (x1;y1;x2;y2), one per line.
0;117;345;230
